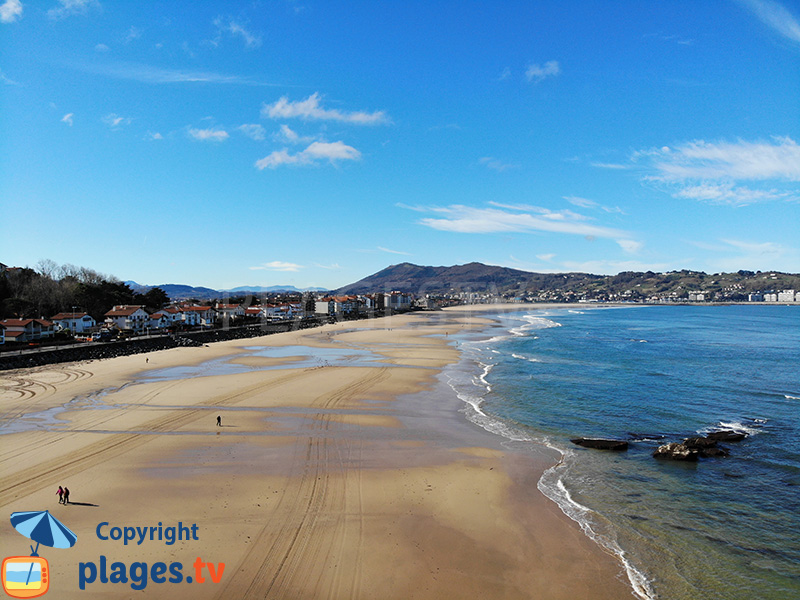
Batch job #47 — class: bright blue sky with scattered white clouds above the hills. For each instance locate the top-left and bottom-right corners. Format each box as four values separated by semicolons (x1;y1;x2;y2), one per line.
0;0;800;289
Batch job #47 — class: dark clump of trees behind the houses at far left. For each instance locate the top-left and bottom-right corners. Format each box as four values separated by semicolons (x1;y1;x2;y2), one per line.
0;260;169;322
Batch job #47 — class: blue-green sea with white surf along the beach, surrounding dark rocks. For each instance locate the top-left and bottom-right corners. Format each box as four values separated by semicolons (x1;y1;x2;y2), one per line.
444;305;800;600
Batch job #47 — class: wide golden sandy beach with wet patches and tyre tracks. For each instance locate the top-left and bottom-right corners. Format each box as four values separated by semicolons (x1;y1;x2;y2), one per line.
0;307;633;600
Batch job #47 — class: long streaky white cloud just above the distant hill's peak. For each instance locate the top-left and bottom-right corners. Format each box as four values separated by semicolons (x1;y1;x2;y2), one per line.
410;204;629;238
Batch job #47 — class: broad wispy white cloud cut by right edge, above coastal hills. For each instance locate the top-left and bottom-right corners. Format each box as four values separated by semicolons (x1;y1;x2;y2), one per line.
632;137;800;206
